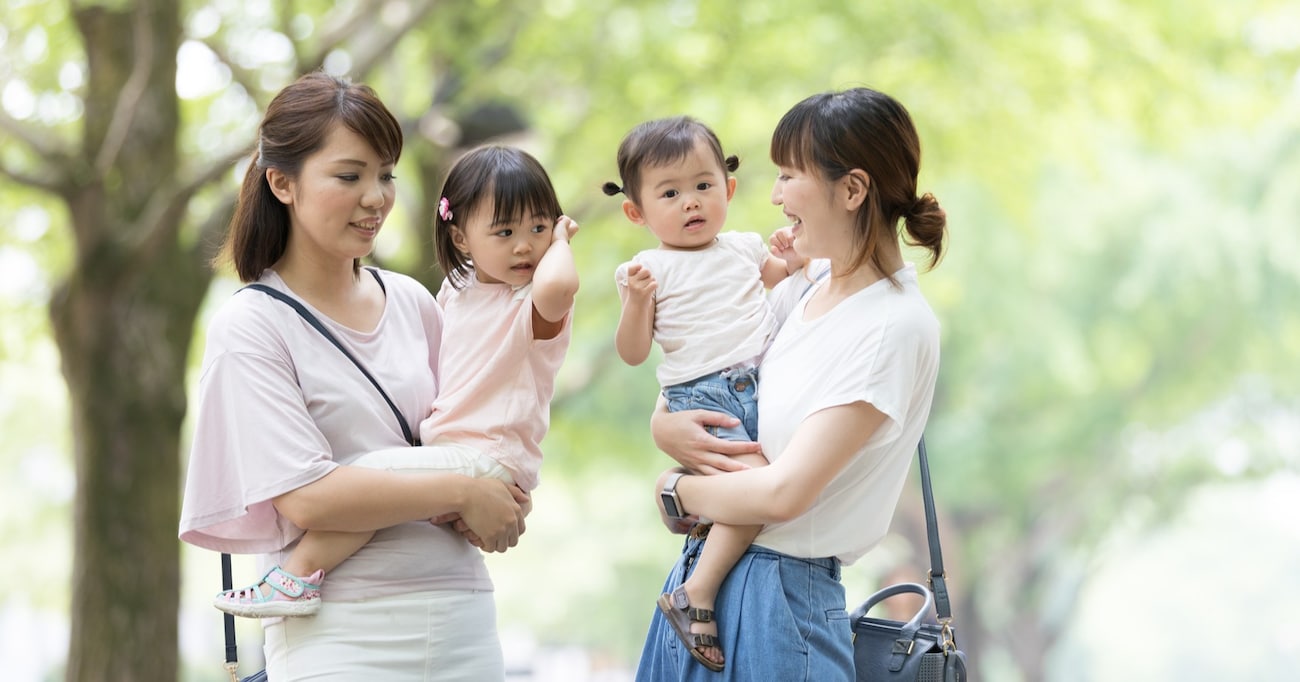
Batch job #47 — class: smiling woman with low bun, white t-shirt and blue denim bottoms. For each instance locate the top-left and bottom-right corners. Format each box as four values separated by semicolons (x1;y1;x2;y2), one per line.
637;88;946;682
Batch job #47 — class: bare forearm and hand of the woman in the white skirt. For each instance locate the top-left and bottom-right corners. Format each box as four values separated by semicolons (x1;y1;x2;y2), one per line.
273;466;524;552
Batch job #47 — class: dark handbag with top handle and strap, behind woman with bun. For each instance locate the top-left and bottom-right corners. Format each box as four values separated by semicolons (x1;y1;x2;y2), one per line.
849;438;969;682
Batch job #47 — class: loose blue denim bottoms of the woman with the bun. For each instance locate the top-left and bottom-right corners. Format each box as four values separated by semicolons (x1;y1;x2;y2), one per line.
636;539;854;682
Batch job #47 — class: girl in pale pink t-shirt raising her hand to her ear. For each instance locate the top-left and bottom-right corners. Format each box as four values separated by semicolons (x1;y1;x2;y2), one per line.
213;145;579;618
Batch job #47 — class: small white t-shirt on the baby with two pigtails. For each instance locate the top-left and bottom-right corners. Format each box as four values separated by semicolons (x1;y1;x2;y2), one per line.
615;233;776;387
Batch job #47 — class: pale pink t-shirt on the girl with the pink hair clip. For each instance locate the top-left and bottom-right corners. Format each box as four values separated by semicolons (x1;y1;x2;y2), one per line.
420;275;573;491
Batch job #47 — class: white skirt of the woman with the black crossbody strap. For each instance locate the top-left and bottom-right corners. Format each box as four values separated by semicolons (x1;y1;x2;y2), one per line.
264;590;506;682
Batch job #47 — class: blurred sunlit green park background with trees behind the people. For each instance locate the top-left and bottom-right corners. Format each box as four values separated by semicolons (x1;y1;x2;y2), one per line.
0;0;1300;682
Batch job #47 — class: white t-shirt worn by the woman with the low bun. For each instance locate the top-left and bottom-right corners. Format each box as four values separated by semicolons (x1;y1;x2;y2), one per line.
754;264;939;565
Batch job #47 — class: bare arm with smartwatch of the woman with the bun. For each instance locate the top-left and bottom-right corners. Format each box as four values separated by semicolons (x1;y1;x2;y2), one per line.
659;401;885;525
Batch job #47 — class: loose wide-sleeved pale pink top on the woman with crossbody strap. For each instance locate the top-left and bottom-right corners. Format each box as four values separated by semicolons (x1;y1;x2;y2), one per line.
181;270;491;600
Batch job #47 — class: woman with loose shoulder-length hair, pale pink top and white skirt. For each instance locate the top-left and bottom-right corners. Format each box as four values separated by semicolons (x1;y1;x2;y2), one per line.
181;73;529;682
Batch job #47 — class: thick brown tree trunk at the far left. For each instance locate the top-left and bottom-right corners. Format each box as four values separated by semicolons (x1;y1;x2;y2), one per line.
49;0;211;681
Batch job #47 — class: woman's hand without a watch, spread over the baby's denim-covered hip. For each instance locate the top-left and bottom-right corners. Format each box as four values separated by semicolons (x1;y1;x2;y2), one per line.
650;398;762;474
